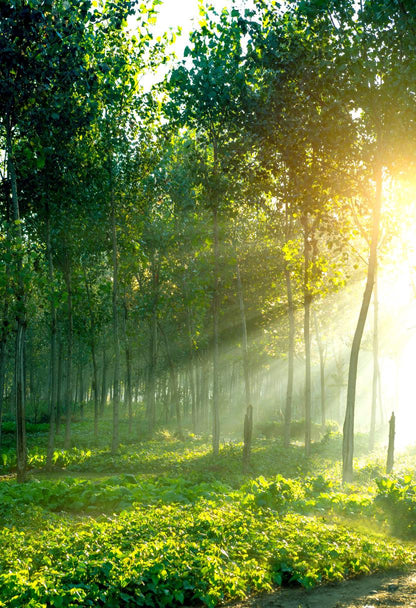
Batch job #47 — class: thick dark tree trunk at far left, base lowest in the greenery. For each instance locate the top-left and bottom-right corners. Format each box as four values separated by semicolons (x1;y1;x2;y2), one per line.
6;116;27;482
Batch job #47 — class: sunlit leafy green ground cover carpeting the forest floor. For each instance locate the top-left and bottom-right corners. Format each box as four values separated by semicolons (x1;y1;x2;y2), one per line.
0;421;416;608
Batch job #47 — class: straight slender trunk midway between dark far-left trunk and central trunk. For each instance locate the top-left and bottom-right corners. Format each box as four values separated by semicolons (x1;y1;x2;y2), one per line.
111;193;120;454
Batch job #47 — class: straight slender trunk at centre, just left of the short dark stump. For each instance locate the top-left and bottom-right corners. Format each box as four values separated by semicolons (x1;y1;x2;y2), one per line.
212;206;220;456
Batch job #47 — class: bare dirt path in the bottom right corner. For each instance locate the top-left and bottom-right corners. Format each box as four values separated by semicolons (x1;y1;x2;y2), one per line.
229;571;416;608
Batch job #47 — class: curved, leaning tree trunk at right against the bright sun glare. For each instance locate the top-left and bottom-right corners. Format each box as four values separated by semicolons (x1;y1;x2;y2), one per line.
342;158;383;483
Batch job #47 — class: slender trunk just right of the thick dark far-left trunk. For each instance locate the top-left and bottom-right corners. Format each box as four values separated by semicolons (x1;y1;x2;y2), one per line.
46;212;58;469
